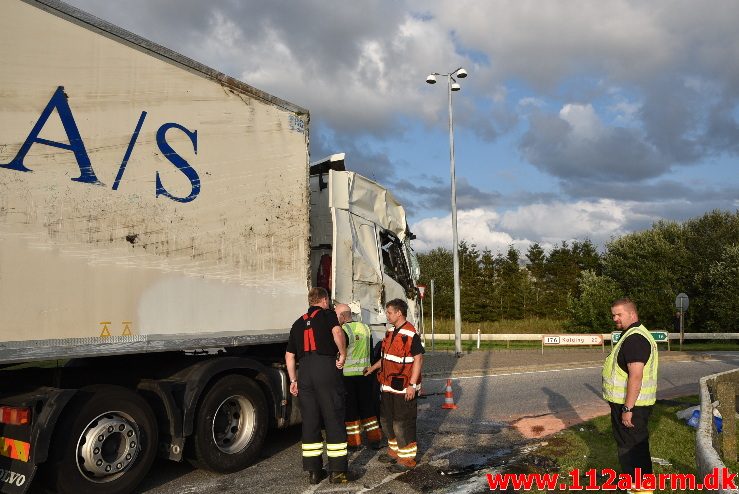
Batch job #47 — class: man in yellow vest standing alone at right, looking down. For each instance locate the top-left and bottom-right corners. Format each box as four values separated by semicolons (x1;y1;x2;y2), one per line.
602;298;659;492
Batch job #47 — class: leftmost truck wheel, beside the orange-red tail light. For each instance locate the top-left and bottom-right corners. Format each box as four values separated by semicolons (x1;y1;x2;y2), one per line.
49;386;158;494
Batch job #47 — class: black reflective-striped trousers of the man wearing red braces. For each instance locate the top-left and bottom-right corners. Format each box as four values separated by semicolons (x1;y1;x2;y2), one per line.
298;353;348;472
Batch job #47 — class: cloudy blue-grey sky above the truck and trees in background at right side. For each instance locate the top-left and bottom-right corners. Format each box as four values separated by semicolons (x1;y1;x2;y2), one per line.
69;0;739;251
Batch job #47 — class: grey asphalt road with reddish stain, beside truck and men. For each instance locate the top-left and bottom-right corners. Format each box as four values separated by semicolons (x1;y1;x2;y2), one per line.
140;352;739;494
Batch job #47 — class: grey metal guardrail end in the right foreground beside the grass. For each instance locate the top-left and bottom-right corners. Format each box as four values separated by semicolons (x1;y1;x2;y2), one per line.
695;370;739;494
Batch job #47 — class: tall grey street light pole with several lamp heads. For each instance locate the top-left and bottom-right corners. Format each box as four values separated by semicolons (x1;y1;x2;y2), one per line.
426;67;467;357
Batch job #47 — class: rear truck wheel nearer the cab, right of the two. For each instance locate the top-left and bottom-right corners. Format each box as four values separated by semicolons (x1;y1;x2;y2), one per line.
191;375;267;473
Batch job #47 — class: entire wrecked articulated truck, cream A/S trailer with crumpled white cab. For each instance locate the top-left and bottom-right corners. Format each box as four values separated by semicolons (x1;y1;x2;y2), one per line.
0;0;418;494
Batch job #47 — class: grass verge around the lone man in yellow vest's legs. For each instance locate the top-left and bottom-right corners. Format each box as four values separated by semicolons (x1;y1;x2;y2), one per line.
506;396;736;494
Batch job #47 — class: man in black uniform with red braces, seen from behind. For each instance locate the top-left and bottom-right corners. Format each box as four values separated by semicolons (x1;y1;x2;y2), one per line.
285;287;349;484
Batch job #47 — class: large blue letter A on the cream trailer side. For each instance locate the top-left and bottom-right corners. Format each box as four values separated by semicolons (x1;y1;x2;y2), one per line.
0;86;102;185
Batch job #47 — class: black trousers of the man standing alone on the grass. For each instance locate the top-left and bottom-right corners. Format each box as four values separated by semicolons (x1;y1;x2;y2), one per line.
609;402;653;481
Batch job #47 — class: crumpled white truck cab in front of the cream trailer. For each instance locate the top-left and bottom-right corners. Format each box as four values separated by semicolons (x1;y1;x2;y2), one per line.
310;153;421;341
